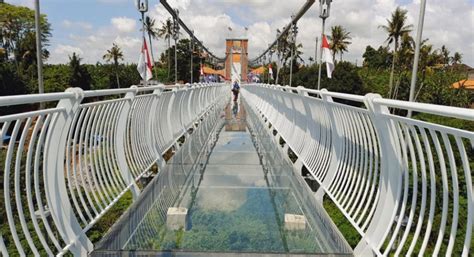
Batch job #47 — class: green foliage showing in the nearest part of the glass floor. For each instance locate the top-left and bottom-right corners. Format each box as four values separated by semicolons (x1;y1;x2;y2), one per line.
126;189;321;253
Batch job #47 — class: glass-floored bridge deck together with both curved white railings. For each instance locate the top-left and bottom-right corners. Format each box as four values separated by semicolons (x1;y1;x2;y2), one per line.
0;84;474;256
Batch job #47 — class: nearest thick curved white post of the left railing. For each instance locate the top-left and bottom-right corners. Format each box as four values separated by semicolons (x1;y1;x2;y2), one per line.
44;88;93;256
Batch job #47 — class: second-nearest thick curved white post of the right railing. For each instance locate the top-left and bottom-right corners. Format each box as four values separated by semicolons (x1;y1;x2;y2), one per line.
315;89;343;203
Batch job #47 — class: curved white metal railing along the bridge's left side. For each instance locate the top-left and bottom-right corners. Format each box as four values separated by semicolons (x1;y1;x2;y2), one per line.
0;84;228;256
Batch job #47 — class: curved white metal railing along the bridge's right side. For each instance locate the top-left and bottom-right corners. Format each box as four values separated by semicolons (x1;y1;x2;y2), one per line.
242;85;474;256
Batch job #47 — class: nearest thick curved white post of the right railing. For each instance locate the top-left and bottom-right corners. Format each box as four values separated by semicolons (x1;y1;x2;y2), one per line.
354;94;402;256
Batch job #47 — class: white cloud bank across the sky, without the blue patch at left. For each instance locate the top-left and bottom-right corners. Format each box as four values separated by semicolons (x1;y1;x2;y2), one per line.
45;0;474;66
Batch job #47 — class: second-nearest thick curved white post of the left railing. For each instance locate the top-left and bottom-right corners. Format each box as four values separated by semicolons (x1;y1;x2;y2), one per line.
115;86;140;200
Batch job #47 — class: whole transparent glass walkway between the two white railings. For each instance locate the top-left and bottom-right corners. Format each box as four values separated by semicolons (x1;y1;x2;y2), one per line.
92;102;351;256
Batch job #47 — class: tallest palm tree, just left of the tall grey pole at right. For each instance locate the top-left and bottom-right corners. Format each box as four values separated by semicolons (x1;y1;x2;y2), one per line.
380;7;413;97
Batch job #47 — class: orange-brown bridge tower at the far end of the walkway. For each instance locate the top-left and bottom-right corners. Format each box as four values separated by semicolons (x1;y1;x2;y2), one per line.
225;38;248;82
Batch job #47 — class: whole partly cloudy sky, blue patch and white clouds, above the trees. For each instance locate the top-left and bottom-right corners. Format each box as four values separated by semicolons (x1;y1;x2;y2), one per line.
5;0;474;67
